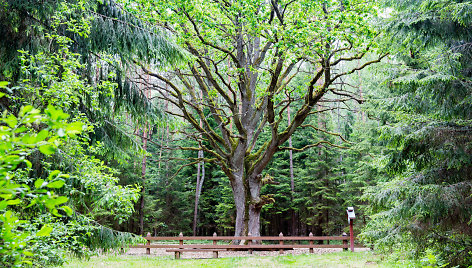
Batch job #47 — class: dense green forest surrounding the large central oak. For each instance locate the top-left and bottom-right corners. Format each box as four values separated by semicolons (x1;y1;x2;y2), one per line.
0;0;472;267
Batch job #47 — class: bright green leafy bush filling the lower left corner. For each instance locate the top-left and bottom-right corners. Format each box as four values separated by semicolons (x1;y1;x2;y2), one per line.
0;82;142;267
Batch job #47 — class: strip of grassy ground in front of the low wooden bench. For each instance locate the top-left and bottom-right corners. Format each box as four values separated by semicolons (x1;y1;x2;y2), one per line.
63;249;415;268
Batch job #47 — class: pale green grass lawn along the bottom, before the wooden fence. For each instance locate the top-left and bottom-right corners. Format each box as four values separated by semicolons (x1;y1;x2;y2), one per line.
63;252;416;268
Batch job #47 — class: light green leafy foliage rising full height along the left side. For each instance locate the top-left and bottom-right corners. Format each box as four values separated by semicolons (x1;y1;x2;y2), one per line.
2;2;154;258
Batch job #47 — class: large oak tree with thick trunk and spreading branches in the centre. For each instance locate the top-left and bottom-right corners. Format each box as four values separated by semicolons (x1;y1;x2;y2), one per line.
122;0;383;236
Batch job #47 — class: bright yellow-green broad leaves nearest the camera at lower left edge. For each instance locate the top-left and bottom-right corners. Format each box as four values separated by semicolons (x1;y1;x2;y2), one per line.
0;90;81;267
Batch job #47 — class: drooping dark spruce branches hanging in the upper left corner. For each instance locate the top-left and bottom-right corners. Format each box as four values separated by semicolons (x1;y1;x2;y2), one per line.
0;0;185;159
